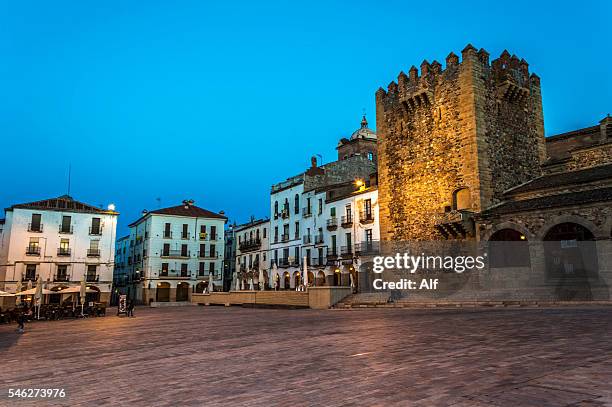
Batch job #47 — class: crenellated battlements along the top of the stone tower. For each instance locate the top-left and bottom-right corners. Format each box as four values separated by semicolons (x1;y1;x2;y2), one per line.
376;44;540;105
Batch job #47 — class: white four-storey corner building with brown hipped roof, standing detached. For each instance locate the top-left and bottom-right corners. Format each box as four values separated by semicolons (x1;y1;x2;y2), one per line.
128;201;227;304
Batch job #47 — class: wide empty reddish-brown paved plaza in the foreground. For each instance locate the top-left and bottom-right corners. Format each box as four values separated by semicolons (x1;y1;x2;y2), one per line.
0;306;612;407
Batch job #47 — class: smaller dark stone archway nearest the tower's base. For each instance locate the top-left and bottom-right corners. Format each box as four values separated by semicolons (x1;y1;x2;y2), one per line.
489;228;531;268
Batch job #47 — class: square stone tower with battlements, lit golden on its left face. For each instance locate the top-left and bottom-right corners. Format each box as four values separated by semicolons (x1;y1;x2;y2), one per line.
376;45;546;240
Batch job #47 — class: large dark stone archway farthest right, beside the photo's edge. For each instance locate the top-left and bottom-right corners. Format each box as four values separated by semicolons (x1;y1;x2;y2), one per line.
543;222;597;300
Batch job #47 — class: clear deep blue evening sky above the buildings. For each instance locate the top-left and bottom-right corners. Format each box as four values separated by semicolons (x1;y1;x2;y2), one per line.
0;0;612;233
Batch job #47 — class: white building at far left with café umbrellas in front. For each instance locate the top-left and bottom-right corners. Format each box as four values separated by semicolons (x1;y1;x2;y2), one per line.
0;195;119;303
